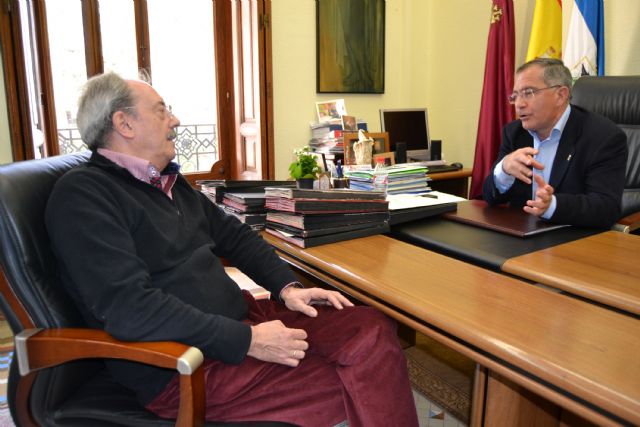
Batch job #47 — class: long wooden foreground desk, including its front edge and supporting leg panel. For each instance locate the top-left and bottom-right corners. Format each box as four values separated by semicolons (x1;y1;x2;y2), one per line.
264;234;640;425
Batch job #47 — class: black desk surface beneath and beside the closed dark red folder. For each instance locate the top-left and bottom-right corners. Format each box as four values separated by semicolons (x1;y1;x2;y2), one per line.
390;217;606;274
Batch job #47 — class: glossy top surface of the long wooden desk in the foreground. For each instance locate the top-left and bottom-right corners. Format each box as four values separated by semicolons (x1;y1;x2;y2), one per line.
265;235;640;423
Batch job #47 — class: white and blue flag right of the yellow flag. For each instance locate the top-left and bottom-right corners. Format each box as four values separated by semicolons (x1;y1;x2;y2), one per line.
562;0;604;79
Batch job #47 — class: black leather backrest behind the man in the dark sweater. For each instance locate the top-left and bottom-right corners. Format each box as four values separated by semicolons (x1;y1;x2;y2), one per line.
0;153;89;333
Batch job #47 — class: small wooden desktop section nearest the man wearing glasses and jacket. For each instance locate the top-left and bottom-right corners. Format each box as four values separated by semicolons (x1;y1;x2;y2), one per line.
502;231;640;316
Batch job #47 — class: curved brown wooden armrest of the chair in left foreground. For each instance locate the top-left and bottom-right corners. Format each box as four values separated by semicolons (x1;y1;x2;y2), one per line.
15;328;204;426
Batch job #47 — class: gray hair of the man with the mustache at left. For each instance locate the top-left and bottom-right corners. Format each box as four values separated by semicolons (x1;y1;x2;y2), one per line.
77;72;135;151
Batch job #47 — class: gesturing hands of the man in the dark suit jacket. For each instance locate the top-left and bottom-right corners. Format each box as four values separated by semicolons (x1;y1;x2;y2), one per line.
502;147;554;217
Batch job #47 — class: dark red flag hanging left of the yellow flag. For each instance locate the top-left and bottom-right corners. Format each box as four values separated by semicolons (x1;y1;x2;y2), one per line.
469;0;515;198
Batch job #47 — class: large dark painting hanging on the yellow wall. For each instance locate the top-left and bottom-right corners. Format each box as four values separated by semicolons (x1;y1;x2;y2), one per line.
316;0;386;93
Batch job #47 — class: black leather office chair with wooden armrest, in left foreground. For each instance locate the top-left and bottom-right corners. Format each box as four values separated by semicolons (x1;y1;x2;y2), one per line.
0;153;286;427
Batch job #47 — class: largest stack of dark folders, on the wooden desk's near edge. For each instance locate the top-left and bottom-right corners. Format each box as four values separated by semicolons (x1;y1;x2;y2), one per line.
265;188;389;248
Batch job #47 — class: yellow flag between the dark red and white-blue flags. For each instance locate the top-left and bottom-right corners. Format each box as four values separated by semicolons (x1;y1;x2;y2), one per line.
527;0;562;61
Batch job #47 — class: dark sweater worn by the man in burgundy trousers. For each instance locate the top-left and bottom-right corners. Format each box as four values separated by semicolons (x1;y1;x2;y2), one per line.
46;153;296;403
